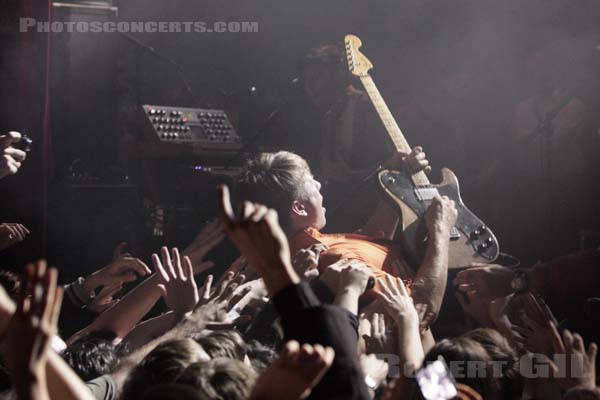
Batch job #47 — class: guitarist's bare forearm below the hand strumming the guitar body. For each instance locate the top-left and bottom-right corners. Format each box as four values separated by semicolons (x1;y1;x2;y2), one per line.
411;231;449;314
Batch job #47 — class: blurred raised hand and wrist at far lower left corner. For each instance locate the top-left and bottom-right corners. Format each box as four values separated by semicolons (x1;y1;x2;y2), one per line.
2;261;62;399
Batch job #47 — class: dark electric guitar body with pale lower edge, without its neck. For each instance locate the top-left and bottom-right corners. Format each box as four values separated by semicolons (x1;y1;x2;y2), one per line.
378;168;499;269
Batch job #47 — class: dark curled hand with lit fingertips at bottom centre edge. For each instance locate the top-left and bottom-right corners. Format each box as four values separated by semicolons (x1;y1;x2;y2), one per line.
250;340;335;400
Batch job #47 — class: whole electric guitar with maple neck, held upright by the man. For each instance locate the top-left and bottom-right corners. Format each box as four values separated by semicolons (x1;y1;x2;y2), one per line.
344;35;499;268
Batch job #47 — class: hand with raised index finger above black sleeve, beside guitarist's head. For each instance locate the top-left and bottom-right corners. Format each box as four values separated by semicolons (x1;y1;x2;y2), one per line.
218;186;300;295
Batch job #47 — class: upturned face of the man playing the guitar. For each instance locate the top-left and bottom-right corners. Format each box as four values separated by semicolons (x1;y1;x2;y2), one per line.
292;174;327;229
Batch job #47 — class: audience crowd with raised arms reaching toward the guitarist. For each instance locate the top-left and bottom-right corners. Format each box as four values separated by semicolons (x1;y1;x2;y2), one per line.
0;129;599;400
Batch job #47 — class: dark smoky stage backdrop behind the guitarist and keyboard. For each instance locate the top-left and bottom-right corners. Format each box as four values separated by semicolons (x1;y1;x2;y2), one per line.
0;0;600;282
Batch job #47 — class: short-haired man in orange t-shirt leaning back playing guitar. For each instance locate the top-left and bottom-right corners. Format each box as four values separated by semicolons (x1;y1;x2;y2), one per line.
236;147;457;332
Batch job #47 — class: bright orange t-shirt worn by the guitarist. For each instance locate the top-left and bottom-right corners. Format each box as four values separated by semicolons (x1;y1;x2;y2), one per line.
290;228;414;296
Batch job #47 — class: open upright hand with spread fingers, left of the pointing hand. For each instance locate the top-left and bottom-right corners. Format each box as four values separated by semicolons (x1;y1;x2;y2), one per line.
152;247;199;318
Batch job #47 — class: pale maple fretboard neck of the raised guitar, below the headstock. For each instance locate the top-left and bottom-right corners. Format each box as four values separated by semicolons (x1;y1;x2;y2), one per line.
360;75;430;186
